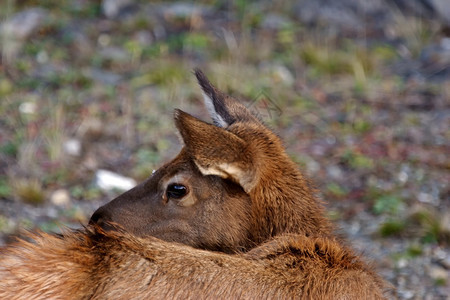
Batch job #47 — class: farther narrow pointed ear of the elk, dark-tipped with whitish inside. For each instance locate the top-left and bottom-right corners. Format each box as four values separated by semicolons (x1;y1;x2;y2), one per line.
194;69;257;128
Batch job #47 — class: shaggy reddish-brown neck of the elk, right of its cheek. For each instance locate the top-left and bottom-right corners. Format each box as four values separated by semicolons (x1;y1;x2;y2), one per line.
250;153;332;242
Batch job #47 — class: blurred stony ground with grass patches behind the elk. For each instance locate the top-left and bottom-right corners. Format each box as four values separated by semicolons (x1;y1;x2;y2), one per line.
0;0;450;299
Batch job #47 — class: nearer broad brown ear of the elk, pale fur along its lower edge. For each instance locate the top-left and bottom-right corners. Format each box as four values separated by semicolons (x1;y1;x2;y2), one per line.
174;109;257;192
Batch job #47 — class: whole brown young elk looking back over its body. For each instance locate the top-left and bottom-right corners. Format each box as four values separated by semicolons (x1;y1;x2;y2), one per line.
0;70;384;299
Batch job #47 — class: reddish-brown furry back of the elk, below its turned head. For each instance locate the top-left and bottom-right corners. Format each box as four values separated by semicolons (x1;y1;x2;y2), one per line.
0;230;383;299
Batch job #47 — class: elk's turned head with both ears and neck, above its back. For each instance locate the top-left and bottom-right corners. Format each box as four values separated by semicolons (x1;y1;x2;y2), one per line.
90;70;330;252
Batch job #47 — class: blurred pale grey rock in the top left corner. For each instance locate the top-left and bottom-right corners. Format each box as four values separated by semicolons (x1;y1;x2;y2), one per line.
1;8;48;40
